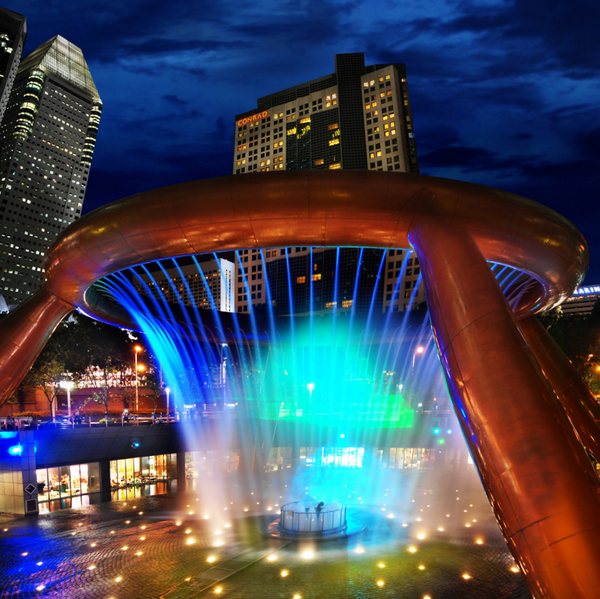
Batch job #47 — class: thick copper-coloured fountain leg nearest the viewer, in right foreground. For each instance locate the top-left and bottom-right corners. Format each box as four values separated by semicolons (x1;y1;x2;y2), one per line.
409;215;600;599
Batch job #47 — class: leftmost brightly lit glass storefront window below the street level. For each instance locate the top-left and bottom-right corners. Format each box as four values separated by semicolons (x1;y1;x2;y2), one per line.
36;462;100;514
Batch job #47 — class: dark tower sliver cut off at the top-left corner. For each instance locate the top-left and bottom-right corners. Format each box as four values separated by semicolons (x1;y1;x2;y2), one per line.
0;7;27;121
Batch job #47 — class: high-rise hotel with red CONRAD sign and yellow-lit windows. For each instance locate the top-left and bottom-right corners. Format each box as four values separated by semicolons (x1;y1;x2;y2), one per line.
233;53;425;313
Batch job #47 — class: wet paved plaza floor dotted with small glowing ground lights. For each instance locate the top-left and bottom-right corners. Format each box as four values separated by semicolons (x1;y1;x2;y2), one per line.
0;477;531;599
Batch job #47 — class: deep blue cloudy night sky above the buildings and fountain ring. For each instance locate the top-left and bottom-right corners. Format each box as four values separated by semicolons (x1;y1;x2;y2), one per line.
9;0;600;284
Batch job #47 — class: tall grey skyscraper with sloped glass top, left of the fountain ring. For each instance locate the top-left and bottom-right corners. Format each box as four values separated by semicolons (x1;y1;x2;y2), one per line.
0;36;102;306
